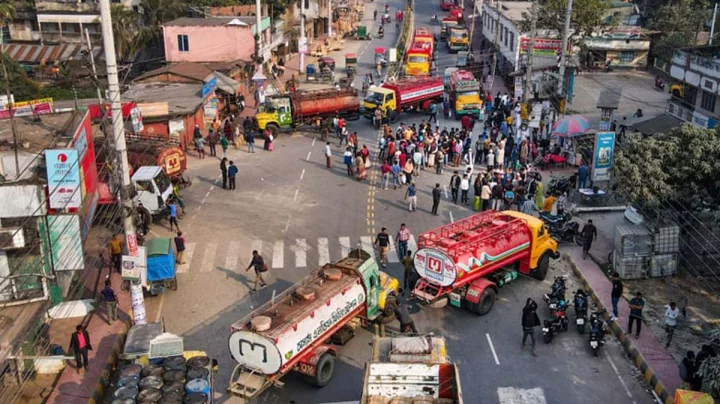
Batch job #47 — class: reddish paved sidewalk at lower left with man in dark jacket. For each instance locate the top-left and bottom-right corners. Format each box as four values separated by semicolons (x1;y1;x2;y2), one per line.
46;268;131;404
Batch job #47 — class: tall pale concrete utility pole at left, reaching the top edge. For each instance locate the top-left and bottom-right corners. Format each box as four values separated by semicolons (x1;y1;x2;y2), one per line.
100;0;147;324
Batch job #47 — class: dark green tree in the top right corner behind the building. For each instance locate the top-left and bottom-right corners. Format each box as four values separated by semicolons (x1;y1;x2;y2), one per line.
648;0;711;62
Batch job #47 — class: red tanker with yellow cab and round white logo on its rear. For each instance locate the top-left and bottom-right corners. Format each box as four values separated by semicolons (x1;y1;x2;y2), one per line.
412;211;559;315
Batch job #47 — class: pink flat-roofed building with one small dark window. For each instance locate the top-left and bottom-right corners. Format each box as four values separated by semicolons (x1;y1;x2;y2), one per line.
163;17;269;63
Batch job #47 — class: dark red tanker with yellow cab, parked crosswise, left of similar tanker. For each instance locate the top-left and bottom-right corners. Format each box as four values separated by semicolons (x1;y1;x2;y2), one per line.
255;88;360;135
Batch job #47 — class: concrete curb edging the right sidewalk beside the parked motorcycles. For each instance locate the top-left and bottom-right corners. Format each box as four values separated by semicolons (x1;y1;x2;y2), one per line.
562;254;675;404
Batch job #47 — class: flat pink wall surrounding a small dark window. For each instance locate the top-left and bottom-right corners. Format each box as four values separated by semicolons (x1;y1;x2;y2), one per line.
163;26;255;63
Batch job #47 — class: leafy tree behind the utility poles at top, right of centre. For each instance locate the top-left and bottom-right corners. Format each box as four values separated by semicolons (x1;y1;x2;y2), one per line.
520;0;610;37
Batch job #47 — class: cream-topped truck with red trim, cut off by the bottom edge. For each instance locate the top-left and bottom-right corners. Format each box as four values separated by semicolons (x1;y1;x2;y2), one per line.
360;335;463;404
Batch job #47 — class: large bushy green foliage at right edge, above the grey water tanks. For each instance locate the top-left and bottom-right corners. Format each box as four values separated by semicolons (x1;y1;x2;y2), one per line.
615;124;720;211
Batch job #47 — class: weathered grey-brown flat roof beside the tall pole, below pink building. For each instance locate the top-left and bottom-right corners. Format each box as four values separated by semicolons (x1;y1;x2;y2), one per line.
122;83;203;116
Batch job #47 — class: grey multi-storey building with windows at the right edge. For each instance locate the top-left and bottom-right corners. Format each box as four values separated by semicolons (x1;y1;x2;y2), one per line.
668;46;720;128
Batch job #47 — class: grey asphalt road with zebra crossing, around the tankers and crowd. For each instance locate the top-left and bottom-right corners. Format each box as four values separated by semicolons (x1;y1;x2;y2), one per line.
139;0;652;404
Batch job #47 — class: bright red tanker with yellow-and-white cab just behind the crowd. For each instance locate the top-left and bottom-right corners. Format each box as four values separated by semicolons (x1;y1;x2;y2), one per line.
363;76;444;122
